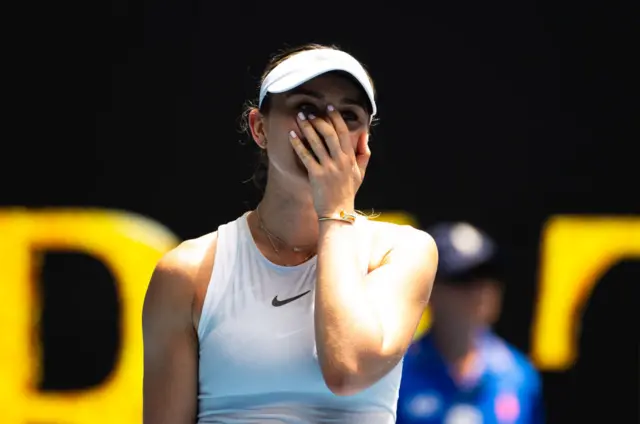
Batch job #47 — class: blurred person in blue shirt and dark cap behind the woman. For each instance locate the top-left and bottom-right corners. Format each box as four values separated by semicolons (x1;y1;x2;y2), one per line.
397;223;544;424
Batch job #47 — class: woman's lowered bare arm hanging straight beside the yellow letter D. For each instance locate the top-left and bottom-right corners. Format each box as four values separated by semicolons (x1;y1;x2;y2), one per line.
142;247;198;424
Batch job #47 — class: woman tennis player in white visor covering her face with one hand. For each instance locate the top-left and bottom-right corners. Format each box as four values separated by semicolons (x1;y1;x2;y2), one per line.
143;45;437;424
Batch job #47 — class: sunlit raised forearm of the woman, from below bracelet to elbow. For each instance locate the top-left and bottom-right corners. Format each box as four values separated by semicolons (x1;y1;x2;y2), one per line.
315;221;383;385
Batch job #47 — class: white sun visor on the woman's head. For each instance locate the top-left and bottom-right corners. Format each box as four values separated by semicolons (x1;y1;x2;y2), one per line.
258;49;377;118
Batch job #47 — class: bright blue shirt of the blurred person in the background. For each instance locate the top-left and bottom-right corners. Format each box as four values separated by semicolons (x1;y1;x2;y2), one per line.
397;331;544;424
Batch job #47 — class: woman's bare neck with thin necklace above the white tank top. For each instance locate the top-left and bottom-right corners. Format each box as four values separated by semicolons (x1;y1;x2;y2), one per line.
259;178;319;248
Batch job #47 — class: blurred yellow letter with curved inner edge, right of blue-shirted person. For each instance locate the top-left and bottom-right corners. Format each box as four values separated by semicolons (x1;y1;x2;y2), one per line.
532;216;640;371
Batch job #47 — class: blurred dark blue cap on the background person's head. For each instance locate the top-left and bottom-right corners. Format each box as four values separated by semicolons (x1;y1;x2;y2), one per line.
428;222;497;282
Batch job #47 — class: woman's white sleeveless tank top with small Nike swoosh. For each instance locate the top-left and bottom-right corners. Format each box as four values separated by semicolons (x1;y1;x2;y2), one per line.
198;214;402;424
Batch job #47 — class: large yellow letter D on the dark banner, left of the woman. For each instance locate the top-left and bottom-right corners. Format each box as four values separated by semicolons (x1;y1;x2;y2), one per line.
0;209;178;424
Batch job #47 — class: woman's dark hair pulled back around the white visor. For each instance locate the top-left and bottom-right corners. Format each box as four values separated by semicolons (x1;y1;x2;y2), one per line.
241;43;375;193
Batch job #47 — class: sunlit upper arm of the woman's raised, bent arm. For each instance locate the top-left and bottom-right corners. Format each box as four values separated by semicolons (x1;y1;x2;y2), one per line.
366;227;438;358
